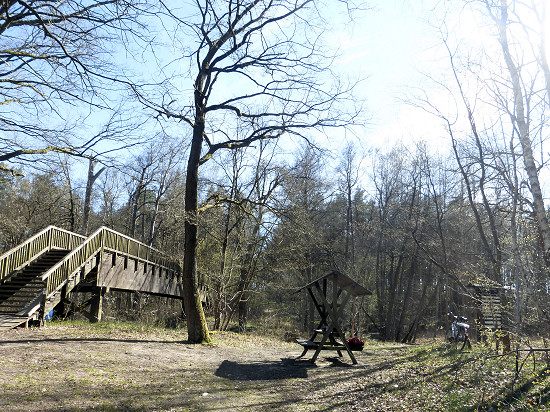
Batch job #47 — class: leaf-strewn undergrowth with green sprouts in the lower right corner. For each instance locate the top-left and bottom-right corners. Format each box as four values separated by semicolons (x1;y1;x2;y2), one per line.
403;343;550;411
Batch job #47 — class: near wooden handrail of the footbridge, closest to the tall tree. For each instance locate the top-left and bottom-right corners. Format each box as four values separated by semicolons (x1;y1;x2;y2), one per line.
42;226;181;297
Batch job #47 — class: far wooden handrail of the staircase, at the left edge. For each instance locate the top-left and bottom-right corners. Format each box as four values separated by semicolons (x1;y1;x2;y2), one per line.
0;226;86;281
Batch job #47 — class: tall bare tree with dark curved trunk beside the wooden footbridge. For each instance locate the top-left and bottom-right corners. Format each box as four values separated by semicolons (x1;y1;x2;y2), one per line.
135;0;357;342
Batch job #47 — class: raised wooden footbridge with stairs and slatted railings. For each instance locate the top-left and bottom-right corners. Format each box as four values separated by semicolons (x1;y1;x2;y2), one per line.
0;226;183;331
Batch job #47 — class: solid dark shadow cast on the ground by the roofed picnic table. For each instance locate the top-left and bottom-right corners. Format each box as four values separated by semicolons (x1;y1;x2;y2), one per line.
214;358;316;381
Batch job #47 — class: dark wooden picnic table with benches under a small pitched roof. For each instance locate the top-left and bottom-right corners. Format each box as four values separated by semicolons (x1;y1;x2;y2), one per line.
298;272;372;364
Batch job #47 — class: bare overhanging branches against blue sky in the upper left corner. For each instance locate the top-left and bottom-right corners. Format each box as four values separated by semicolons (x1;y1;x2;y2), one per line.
0;0;144;174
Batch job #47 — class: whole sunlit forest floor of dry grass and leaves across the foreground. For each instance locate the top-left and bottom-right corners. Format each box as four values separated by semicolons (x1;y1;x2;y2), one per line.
0;323;550;411
